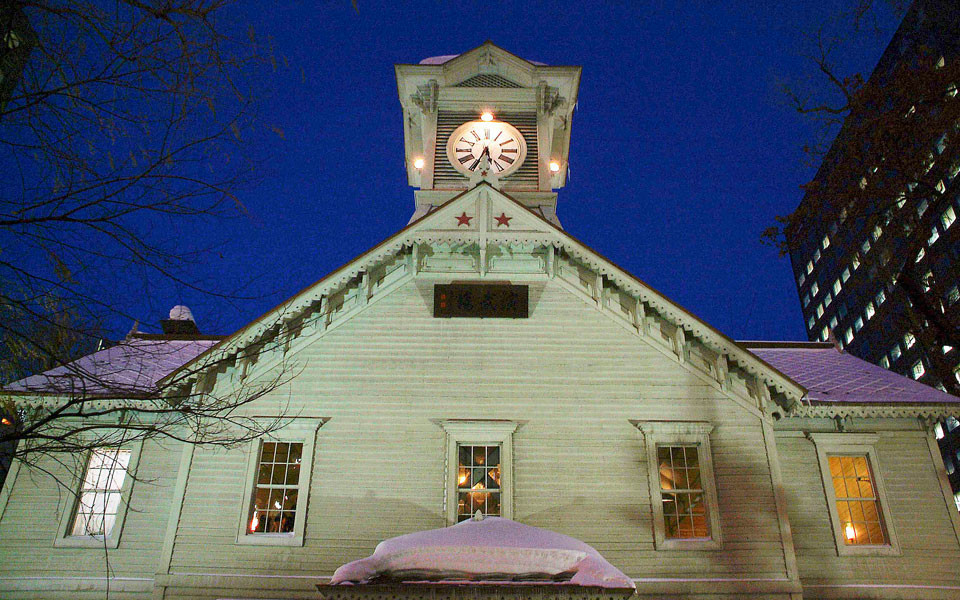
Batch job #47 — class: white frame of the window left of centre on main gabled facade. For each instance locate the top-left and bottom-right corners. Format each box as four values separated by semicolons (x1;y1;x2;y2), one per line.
236;418;327;546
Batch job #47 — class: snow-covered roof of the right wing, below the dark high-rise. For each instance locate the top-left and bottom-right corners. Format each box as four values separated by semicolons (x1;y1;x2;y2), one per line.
740;342;960;404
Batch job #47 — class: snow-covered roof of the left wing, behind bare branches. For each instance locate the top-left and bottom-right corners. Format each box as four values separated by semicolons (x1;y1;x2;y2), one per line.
4;336;219;396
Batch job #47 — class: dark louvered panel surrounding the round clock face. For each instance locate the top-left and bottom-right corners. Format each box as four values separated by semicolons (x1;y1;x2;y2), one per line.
433;110;540;190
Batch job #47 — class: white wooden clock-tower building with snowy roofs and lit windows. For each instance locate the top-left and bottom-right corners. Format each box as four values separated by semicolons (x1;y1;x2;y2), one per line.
0;43;960;600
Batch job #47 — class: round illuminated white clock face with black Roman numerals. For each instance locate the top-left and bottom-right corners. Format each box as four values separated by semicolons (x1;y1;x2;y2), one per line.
447;121;527;177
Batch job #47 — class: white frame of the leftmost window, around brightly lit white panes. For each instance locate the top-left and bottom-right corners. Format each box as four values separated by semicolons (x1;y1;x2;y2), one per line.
53;440;143;550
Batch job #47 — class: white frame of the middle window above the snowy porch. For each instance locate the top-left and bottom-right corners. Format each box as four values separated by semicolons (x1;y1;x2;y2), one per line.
440;419;520;526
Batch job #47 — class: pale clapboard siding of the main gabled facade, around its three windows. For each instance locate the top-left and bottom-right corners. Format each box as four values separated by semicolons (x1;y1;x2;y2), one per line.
165;283;786;592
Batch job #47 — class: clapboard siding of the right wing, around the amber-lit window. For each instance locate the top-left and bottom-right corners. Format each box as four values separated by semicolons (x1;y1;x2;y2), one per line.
777;432;960;597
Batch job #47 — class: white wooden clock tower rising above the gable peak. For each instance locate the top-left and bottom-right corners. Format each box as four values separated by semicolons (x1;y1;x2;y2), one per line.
395;42;580;225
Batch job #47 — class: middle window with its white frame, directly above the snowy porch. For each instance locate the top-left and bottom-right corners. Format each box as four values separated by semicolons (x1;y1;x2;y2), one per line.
442;420;517;524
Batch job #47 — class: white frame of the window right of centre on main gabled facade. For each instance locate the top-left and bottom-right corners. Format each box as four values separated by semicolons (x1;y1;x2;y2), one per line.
633;421;723;550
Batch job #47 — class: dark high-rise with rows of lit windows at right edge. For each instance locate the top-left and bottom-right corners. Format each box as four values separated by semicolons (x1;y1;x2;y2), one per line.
787;0;960;494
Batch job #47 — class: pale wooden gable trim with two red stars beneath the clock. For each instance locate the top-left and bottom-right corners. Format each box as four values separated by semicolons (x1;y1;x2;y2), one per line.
161;182;806;404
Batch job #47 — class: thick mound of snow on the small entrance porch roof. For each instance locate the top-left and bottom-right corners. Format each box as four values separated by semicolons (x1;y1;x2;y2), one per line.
330;517;635;589
